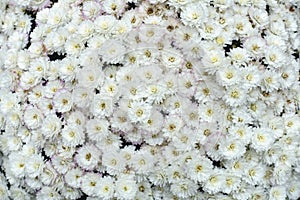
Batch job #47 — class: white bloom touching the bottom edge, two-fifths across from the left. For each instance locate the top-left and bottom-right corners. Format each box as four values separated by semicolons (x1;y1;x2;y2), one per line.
115;174;138;199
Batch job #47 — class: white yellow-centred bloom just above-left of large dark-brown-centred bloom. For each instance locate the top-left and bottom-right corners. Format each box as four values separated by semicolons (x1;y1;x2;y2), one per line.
61;125;85;147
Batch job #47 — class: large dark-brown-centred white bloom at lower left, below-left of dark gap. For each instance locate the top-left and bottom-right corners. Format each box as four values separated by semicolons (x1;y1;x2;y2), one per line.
75;144;101;170
